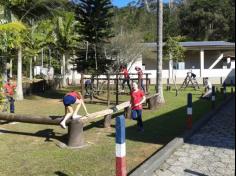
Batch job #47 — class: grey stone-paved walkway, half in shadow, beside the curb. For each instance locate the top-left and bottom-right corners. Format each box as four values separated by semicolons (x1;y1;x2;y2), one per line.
153;97;235;176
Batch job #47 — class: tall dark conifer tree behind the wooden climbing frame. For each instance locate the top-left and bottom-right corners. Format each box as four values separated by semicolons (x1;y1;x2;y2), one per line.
76;0;112;73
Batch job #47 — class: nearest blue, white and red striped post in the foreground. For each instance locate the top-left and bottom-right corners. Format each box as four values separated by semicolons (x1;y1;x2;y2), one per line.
116;115;127;176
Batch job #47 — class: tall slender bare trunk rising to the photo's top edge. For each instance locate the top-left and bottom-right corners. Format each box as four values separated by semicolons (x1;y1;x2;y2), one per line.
156;0;165;104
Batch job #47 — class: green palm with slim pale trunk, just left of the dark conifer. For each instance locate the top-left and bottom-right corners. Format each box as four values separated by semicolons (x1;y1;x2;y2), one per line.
55;13;79;87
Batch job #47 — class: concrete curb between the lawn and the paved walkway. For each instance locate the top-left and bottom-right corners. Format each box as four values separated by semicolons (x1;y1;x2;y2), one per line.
129;95;235;176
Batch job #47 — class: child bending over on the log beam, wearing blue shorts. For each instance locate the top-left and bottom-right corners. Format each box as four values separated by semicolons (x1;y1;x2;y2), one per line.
60;91;88;129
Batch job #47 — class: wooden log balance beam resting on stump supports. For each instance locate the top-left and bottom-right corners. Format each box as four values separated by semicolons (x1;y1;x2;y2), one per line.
0;94;159;148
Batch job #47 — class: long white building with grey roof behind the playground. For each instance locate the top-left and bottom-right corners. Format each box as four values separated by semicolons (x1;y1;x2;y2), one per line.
65;41;235;84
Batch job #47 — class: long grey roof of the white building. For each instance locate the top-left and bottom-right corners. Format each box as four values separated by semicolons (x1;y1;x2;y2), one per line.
145;41;235;50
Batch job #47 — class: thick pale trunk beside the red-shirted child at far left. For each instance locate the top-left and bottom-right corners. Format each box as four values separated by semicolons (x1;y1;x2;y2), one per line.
16;46;24;100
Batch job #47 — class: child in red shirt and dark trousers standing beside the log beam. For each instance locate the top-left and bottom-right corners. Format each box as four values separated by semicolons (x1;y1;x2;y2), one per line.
131;83;146;131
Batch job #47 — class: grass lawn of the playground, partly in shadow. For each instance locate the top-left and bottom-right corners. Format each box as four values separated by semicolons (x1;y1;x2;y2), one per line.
0;86;232;176
